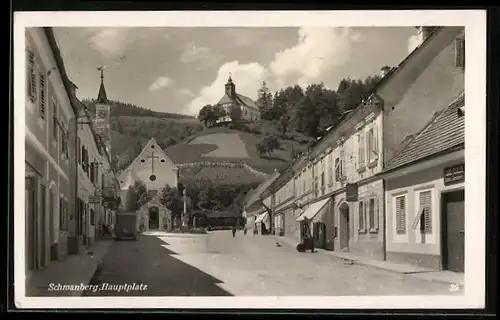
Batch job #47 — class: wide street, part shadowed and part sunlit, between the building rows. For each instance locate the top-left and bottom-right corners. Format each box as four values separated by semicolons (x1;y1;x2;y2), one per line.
80;231;463;296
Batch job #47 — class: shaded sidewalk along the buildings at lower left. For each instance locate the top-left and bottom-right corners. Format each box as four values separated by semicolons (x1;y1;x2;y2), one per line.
26;240;113;297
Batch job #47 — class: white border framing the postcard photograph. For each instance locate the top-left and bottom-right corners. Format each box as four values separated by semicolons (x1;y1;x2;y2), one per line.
14;10;486;309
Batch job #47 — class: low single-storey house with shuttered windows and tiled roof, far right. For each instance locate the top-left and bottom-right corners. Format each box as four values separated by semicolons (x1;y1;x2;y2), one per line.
384;95;465;272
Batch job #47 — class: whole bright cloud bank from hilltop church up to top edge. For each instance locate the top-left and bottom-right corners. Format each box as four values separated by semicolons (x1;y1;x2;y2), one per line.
186;28;362;114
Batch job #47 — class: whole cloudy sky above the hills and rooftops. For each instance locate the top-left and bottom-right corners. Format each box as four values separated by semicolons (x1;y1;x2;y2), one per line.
54;27;418;115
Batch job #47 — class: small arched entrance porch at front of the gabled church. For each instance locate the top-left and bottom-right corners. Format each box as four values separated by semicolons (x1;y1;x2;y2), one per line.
139;197;172;231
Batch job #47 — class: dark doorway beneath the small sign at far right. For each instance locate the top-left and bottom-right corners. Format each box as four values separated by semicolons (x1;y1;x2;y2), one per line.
442;190;465;272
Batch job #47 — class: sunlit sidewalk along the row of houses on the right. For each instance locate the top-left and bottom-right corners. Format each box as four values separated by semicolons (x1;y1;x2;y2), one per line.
274;236;464;286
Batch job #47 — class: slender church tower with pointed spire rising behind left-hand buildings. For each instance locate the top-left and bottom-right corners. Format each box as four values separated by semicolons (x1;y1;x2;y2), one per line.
94;67;111;154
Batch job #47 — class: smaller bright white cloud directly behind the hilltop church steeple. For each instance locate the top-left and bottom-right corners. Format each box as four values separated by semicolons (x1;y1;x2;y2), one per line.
186;61;267;115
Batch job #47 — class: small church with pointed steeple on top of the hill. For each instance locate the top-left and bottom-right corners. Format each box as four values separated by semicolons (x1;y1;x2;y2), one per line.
217;74;260;122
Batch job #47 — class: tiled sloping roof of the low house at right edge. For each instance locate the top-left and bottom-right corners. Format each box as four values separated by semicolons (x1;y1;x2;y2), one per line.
384;93;465;171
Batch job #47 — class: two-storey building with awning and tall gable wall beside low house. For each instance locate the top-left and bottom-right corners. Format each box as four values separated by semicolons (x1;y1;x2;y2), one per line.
252;27;465;259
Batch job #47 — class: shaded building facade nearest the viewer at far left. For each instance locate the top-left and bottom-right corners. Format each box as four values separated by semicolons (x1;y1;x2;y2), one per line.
25;28;76;274
